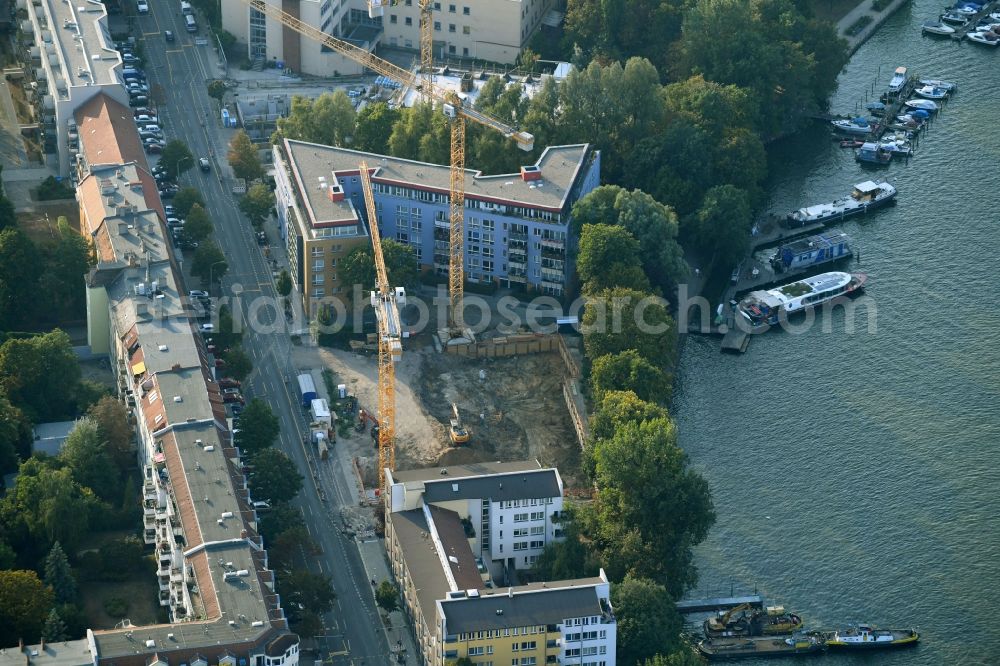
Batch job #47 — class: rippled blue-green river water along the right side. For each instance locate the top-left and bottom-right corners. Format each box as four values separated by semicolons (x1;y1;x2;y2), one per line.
674;0;1000;666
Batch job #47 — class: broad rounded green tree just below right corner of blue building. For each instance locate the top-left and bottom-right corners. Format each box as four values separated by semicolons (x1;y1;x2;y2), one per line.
582;289;677;370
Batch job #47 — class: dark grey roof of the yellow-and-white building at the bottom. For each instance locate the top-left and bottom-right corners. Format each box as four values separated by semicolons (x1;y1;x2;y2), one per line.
439;583;604;635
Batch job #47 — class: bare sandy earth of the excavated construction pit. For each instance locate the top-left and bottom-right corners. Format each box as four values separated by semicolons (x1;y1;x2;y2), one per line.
294;338;583;487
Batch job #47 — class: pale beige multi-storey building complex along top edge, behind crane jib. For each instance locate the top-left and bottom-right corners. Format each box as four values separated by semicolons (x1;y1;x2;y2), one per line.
222;0;555;76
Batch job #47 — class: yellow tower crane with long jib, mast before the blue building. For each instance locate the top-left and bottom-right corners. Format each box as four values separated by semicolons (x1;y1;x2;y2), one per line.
243;0;535;331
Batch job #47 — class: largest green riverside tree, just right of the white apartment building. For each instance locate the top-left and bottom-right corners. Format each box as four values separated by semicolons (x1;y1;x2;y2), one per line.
587;418;715;592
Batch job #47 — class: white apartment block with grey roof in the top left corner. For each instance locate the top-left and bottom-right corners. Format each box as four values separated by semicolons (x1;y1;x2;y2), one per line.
17;0;128;176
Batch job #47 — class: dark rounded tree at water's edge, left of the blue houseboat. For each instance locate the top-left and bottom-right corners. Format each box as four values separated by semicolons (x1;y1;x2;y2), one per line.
693;185;753;267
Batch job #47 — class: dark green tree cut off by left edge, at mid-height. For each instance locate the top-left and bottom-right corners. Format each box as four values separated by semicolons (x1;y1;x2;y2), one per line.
0;228;42;330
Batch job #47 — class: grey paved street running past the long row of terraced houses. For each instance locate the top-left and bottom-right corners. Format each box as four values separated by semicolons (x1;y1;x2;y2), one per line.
138;7;389;664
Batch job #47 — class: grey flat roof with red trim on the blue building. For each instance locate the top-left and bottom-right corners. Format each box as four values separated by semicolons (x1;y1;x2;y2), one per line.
284;139;589;212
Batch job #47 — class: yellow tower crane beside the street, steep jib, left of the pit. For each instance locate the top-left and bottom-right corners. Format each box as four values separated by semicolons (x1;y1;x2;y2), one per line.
358;162;406;488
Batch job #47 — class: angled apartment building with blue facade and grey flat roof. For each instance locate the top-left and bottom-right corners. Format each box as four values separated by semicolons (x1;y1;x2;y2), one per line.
274;139;601;312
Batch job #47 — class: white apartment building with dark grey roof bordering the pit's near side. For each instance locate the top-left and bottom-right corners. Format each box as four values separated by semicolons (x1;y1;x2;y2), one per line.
386;461;563;580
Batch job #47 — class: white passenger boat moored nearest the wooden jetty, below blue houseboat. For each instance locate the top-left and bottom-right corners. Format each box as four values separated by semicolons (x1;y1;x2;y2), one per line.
736;271;868;328
